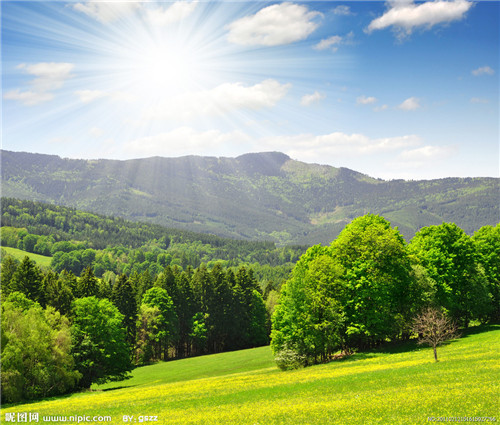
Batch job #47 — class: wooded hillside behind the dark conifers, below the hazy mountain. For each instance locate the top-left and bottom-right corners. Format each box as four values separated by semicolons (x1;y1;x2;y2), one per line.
1;198;306;289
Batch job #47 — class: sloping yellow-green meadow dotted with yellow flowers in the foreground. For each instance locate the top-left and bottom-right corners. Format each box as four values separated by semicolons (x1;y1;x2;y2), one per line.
2;326;500;425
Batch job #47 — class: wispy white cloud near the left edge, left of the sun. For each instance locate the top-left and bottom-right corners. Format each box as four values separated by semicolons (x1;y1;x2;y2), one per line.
3;62;74;106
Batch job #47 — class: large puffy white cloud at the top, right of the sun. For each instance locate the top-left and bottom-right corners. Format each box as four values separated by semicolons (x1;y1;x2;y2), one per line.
227;2;322;46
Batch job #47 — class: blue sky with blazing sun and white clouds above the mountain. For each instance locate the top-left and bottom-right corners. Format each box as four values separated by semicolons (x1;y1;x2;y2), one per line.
0;0;500;180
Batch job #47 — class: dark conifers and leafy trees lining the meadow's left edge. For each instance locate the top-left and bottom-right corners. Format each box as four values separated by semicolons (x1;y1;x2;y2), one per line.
1;256;270;402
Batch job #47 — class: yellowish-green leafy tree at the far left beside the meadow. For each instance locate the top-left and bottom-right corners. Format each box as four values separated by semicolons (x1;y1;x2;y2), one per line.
1;292;80;402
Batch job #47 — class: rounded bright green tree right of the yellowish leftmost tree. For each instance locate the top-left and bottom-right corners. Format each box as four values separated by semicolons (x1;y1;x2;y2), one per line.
71;297;132;388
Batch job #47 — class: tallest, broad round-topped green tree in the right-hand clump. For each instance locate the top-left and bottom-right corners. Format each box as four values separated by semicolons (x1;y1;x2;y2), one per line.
330;214;414;348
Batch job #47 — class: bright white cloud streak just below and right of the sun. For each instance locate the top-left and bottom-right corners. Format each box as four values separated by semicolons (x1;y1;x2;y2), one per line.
144;79;291;119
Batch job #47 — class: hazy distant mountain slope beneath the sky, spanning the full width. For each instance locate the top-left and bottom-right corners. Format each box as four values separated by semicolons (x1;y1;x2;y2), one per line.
1;151;500;244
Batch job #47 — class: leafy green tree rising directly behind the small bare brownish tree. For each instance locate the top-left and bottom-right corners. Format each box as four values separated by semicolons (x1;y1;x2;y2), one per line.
409;223;491;327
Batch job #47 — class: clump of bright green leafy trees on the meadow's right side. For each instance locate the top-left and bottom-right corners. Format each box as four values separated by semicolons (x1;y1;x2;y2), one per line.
271;215;500;368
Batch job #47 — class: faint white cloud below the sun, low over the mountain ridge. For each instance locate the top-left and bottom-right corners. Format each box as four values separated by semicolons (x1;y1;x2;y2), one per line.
125;127;250;157
